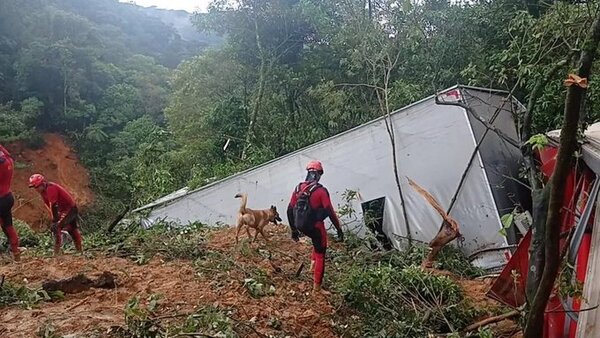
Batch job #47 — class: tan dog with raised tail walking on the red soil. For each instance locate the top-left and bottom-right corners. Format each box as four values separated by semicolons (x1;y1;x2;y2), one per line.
235;194;281;244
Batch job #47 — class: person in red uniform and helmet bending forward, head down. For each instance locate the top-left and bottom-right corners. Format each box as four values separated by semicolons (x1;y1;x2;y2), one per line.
29;174;83;255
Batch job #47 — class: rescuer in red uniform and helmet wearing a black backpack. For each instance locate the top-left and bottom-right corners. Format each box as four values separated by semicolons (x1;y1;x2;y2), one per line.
287;161;344;292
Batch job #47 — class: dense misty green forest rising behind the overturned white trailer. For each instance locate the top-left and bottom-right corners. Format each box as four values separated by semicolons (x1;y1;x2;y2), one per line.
0;0;598;226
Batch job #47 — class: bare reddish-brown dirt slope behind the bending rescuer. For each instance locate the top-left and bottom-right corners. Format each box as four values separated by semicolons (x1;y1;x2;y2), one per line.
7;134;94;229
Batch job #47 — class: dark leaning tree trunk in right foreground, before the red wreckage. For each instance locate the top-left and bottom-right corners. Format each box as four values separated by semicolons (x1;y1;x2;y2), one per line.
524;11;600;338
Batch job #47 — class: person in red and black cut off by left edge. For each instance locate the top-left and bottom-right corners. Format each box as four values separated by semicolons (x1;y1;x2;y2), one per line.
0;145;20;261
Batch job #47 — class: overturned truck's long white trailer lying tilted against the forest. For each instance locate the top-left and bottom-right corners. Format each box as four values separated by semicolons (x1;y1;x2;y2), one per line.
135;86;530;269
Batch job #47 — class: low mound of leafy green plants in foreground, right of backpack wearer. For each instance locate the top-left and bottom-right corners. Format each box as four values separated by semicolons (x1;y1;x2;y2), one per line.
339;264;477;337
